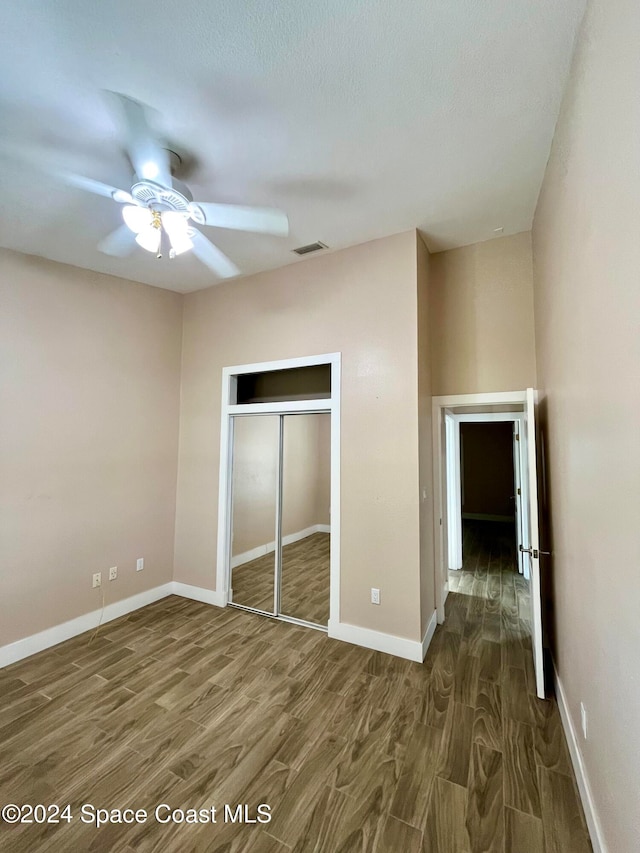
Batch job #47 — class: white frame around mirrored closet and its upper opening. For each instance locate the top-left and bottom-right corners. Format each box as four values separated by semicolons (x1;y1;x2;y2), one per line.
216;352;342;623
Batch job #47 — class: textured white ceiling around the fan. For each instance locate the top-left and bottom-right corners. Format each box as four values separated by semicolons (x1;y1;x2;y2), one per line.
0;0;584;291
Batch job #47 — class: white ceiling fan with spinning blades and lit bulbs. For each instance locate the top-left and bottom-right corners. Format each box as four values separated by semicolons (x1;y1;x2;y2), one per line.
54;92;289;278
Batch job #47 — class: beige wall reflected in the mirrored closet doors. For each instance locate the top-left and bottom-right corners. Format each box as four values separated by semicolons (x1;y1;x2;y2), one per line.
231;413;331;556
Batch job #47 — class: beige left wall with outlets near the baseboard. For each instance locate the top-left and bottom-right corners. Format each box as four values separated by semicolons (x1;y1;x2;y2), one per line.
0;250;182;645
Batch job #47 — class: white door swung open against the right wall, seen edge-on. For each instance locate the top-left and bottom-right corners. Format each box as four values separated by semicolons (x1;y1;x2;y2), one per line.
523;388;545;699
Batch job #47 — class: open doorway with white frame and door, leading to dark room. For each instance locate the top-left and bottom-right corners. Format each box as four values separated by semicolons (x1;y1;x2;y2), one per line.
433;389;546;698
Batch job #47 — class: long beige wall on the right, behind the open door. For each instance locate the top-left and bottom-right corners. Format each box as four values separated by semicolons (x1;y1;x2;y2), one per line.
533;0;640;853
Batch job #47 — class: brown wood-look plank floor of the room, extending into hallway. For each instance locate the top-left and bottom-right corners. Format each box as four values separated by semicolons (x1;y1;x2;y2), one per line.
0;531;591;853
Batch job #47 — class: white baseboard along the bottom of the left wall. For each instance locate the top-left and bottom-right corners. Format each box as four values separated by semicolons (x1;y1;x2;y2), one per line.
0;582;174;667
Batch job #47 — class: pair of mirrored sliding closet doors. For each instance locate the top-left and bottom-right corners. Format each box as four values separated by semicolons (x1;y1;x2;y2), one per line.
230;412;331;627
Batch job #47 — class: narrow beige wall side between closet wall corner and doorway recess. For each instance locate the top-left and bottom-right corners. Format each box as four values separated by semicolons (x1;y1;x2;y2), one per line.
416;234;436;636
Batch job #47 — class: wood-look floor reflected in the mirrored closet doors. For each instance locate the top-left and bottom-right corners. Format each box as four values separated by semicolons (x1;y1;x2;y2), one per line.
232;533;330;626
